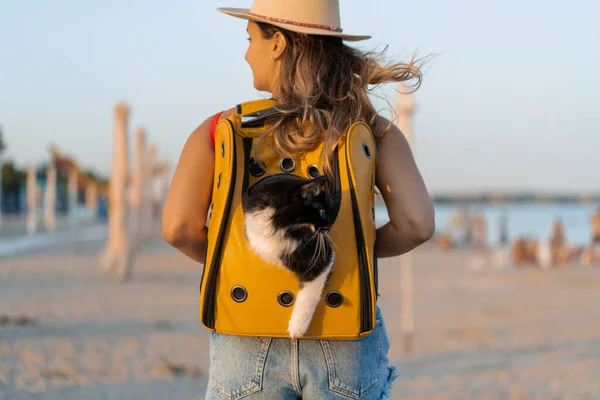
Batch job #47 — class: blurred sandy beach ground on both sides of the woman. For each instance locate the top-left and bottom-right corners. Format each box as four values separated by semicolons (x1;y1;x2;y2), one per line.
0;238;600;400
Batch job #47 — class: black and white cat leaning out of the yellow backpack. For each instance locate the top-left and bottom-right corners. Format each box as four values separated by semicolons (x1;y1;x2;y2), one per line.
242;174;335;338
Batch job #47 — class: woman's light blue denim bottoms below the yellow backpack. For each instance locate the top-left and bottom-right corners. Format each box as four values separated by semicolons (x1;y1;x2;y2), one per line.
206;307;396;400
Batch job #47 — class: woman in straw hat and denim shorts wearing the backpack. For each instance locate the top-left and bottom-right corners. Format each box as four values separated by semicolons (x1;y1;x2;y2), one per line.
163;0;434;399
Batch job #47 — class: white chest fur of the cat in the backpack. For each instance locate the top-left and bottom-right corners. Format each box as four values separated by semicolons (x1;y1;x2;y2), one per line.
246;208;298;265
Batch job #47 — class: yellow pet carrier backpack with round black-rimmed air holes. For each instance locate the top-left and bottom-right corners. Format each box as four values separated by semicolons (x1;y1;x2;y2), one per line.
200;100;377;340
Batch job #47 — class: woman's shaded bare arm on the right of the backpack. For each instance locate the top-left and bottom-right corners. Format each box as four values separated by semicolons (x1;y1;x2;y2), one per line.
376;117;435;258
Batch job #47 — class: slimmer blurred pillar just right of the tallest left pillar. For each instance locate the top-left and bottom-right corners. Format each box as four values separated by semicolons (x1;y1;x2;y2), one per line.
130;128;146;251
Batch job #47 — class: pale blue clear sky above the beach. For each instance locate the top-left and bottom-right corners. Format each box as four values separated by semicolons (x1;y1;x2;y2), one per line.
0;0;600;192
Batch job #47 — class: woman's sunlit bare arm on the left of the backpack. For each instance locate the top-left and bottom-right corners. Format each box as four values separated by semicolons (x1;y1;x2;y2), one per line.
162;108;235;263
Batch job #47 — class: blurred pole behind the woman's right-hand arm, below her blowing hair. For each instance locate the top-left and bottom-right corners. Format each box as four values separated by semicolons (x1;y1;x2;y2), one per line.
395;84;415;354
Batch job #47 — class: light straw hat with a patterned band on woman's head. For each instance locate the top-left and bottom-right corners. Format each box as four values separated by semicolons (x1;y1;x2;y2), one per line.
217;0;371;42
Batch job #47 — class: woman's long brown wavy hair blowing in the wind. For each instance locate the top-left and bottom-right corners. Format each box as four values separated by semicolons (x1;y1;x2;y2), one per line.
257;22;422;176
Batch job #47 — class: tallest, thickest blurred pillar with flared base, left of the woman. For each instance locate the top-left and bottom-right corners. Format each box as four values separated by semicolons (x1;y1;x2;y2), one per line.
101;103;133;281
